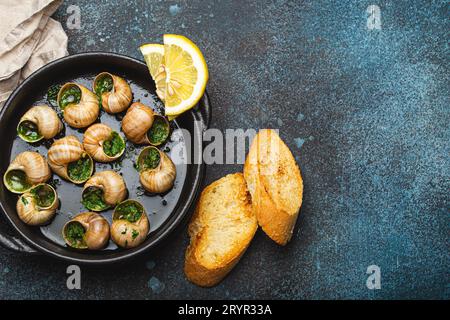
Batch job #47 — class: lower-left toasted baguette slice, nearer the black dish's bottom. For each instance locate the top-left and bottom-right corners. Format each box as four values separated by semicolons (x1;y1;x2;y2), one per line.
184;173;258;287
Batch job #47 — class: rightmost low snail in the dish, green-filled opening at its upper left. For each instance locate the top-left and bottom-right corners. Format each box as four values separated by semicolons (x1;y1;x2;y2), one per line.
137;146;177;193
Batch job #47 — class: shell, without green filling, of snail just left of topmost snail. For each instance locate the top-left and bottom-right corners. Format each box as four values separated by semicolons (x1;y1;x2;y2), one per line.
57;82;100;128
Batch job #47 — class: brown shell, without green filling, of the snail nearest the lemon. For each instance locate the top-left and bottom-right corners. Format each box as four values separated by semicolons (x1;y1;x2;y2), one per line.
122;102;154;144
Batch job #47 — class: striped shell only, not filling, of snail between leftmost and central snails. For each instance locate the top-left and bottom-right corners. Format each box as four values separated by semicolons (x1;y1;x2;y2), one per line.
48;136;94;184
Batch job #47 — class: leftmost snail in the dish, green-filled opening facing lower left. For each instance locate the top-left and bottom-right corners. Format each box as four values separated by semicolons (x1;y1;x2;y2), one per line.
3;151;52;194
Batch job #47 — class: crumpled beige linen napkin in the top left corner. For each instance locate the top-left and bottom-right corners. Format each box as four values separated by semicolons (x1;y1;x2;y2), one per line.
0;0;68;108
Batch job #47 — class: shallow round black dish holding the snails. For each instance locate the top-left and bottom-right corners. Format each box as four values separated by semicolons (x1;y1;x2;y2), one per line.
0;52;211;264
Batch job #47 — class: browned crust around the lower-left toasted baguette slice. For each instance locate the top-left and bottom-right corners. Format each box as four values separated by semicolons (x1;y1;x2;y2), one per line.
184;173;258;287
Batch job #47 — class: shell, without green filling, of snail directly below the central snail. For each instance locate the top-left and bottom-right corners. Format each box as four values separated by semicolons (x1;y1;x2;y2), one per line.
82;170;127;211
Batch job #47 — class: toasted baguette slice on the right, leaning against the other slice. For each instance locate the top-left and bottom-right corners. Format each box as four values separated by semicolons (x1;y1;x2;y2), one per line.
244;129;303;245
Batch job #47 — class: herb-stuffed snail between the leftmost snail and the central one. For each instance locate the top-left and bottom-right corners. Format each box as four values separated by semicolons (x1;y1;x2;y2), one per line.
48;136;94;184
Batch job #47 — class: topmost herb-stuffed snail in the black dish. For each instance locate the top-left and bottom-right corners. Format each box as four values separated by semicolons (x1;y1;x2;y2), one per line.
93;72;133;113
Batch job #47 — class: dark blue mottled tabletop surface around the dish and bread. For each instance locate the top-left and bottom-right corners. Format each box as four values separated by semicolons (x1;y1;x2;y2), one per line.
0;0;450;299
